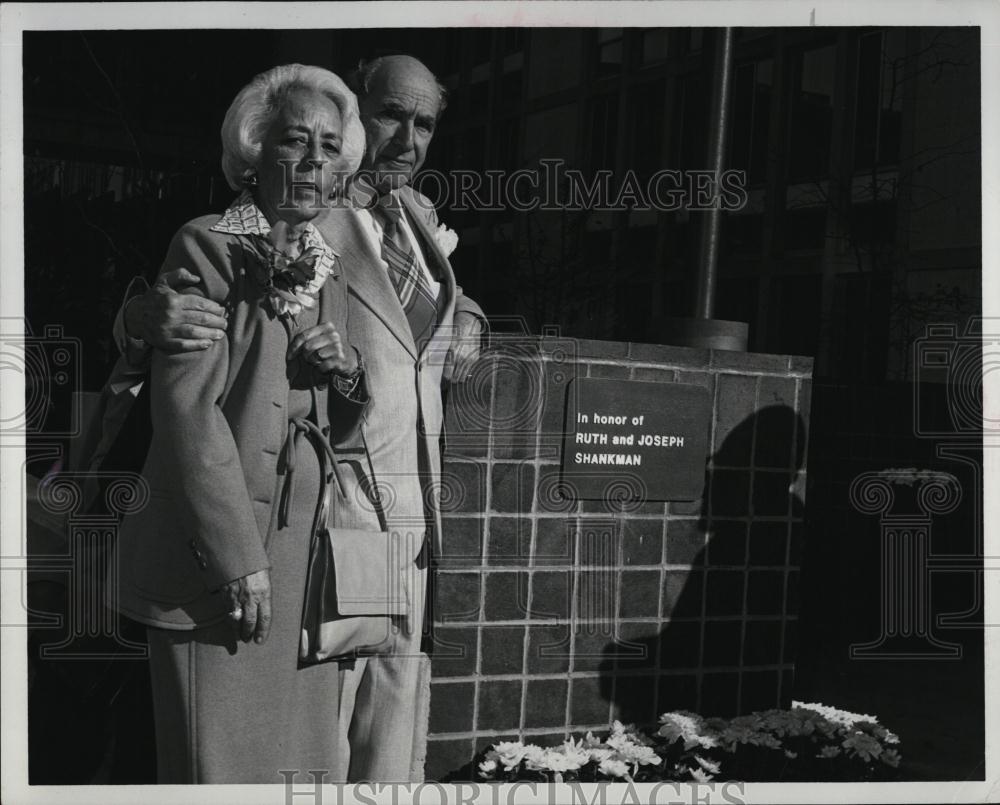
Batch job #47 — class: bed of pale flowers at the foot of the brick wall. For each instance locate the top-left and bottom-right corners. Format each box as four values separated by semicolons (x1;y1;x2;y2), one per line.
479;702;900;782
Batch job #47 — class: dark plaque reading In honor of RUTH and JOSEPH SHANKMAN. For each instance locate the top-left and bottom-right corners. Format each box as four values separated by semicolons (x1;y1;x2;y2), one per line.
562;378;712;501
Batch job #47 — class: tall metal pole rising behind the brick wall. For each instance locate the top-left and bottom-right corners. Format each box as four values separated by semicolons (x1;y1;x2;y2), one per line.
695;28;734;319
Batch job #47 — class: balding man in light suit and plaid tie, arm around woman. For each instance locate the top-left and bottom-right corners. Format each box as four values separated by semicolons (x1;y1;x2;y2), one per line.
103;56;483;781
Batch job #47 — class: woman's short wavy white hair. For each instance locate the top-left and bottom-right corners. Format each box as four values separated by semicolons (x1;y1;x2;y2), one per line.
222;64;365;190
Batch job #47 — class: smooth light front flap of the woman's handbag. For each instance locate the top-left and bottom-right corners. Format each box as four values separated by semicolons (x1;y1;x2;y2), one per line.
326;528;411;615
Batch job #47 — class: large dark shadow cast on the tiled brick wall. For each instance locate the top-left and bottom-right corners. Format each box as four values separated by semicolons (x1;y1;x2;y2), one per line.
599;405;805;725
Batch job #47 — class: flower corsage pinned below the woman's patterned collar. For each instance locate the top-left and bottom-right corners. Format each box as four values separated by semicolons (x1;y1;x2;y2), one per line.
253;221;337;319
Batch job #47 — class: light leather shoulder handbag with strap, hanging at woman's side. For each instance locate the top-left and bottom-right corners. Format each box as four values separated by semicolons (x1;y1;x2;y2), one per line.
299;420;412;664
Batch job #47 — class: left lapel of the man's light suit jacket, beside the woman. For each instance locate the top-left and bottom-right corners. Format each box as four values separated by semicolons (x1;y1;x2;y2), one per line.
317;208;417;358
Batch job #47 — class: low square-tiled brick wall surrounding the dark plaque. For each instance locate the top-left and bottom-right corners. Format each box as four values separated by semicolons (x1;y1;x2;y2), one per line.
425;338;812;779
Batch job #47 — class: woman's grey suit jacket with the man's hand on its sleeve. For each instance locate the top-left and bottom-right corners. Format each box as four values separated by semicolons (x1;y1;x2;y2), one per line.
109;215;364;629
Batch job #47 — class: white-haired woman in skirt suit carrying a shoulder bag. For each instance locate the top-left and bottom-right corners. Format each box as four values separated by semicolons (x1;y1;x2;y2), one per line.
112;65;366;783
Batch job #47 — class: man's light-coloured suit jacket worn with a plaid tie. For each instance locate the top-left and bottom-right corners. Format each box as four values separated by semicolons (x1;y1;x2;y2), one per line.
317;187;483;564
